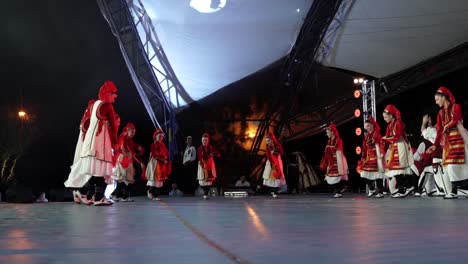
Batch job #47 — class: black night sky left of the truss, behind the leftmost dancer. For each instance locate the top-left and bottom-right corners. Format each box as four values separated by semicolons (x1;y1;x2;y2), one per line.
0;0;152;185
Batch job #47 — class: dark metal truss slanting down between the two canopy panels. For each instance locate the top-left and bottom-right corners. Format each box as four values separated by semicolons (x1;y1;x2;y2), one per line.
248;0;343;177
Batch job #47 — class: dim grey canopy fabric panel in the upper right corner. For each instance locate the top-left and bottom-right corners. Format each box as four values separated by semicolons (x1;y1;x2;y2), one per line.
324;0;468;78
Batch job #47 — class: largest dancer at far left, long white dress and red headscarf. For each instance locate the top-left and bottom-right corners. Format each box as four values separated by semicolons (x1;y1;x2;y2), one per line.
65;81;117;205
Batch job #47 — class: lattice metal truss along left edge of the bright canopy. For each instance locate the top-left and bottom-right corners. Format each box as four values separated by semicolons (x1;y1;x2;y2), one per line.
97;0;179;156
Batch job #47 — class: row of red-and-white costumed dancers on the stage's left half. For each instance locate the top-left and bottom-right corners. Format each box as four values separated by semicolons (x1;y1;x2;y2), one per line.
64;81;220;206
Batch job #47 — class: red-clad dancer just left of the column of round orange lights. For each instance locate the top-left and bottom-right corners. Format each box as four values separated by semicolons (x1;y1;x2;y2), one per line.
320;124;349;198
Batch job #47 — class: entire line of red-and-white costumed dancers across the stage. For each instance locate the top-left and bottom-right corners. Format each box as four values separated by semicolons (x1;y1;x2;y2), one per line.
65;81;468;206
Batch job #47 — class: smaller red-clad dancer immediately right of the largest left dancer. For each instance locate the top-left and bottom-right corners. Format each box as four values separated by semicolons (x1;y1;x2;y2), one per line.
111;123;145;202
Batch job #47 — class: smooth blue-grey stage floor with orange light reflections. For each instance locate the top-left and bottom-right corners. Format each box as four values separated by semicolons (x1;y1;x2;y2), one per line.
0;195;468;264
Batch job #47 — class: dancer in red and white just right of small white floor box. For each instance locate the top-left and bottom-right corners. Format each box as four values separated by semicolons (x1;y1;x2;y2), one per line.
263;132;286;198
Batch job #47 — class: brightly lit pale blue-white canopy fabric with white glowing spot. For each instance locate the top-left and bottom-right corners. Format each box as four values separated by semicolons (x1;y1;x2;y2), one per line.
138;0;313;105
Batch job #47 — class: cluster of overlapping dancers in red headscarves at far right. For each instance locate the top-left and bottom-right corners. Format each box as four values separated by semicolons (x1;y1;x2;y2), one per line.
352;87;468;199
